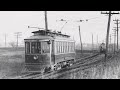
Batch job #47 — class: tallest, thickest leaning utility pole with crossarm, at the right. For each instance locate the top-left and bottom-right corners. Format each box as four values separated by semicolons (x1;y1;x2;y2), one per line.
101;11;119;60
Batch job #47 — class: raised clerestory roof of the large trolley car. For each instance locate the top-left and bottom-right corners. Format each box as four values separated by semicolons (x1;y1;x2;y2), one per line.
25;30;73;41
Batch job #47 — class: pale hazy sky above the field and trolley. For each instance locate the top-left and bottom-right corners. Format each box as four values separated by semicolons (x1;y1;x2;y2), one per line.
0;11;120;46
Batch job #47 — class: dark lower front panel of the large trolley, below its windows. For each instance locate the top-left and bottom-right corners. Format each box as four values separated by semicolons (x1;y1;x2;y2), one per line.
25;55;50;71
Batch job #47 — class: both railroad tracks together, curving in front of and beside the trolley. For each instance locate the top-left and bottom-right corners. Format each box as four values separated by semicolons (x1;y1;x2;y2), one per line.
12;54;116;79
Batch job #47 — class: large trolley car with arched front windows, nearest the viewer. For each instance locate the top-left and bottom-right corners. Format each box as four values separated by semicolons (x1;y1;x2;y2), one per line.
24;30;75;71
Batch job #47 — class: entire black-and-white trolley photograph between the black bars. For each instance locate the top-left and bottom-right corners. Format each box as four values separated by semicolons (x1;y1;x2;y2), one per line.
0;11;120;79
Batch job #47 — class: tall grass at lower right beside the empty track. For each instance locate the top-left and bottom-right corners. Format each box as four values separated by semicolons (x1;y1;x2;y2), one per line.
59;53;120;79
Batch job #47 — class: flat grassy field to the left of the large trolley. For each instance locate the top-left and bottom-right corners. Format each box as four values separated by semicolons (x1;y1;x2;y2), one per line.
0;48;25;79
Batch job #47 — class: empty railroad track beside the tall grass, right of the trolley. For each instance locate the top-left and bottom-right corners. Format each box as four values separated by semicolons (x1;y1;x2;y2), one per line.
38;55;113;79
